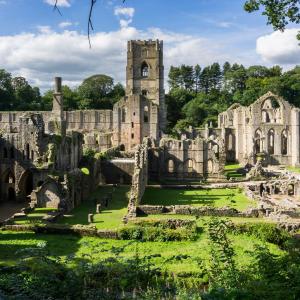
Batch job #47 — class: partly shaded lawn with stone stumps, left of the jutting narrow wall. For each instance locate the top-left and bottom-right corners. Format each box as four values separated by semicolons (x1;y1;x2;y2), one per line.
58;186;130;229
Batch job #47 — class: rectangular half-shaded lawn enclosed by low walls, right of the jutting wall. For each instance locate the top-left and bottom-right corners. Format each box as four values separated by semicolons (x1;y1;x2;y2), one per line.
142;187;257;210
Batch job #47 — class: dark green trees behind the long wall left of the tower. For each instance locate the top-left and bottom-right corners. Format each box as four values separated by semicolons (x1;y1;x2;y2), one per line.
0;69;125;111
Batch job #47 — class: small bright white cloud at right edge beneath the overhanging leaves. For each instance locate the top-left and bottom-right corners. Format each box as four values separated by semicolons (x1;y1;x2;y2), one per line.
256;28;300;65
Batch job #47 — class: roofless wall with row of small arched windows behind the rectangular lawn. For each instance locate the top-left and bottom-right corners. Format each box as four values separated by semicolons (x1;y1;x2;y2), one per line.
149;137;226;180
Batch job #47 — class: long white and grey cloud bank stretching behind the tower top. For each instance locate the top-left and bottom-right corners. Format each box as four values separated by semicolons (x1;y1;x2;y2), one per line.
0;26;252;91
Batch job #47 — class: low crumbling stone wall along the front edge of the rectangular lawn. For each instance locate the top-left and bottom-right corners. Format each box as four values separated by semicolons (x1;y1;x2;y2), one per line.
137;205;265;218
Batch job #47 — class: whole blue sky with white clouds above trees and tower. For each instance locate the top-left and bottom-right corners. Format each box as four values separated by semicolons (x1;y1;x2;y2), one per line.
0;0;300;90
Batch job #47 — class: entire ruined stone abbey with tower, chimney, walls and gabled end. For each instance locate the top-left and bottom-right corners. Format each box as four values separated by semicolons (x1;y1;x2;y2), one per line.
0;40;300;223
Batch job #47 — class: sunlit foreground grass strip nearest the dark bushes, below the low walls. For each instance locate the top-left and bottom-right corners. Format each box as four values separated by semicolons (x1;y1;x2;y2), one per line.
0;223;283;276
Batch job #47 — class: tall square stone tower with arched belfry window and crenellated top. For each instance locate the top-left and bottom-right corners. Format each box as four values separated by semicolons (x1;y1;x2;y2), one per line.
113;40;166;150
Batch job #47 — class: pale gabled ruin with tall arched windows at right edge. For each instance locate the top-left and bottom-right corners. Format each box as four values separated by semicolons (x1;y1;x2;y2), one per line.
218;92;300;166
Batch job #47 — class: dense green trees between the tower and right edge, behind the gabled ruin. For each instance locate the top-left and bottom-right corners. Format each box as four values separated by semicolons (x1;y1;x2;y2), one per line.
166;62;300;133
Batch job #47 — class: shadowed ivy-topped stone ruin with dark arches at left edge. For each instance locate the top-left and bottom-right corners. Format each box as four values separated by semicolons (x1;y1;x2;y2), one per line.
0;112;82;207
